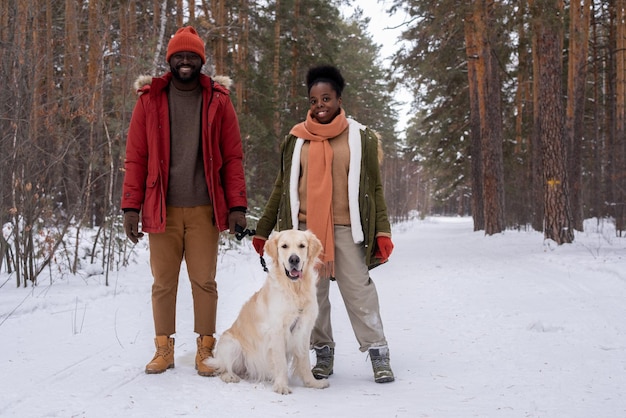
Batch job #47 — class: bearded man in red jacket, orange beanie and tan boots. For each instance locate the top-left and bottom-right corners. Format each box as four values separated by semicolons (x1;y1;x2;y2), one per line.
122;26;247;376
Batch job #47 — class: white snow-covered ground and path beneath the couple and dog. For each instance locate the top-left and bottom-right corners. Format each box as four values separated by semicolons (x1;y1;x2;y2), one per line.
0;218;626;418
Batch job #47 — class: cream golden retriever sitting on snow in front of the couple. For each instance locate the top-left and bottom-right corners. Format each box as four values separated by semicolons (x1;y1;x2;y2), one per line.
205;229;328;395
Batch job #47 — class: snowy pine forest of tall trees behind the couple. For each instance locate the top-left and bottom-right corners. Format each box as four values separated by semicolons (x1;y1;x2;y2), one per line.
0;0;626;286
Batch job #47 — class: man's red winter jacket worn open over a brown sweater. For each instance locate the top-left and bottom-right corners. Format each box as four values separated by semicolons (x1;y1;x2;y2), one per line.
122;72;248;233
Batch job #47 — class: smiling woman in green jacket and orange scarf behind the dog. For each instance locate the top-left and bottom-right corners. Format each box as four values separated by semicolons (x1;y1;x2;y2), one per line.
253;65;394;383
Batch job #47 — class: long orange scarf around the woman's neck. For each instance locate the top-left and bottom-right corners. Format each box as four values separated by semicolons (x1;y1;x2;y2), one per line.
290;109;348;277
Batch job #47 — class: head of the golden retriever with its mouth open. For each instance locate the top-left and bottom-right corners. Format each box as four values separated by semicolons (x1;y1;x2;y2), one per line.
265;229;322;280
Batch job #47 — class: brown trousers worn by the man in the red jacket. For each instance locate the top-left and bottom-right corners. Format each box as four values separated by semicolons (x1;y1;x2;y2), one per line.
149;205;219;336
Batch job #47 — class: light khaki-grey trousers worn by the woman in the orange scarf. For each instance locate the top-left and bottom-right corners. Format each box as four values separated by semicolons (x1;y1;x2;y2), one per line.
311;225;387;351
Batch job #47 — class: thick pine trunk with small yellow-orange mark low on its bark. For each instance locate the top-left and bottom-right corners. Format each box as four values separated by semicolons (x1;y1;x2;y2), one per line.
530;0;574;244
